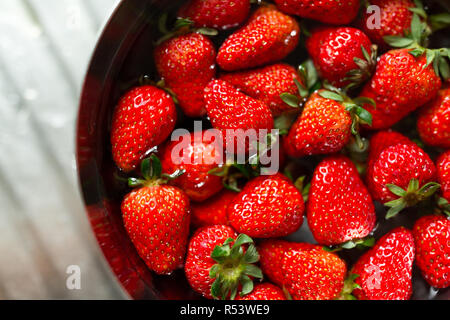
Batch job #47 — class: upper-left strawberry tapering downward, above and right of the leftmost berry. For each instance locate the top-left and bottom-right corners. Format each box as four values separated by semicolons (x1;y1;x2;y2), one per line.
155;33;216;117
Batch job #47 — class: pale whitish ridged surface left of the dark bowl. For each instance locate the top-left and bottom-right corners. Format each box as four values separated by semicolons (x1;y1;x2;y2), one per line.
0;0;121;299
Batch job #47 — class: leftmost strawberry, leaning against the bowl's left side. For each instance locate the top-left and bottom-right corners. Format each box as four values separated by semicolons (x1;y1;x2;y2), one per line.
111;86;177;172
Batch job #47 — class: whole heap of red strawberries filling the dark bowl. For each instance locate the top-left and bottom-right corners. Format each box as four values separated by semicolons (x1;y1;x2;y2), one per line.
107;0;450;300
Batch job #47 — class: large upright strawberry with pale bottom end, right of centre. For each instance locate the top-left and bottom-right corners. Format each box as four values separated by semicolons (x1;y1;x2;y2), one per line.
307;156;376;245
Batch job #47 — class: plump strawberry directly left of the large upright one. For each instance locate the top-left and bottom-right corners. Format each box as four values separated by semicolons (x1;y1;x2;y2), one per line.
227;173;305;238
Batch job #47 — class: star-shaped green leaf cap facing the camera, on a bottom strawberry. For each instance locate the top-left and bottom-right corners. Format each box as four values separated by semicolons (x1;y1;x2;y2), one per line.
209;234;263;300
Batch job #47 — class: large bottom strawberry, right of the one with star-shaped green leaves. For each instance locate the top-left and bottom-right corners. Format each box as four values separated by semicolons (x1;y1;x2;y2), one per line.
258;240;347;300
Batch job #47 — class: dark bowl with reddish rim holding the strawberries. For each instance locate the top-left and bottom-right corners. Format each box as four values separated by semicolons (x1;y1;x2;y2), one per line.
76;0;450;300
